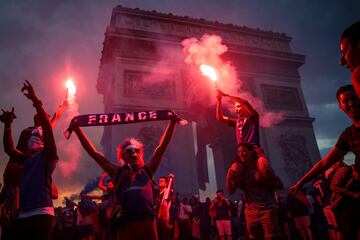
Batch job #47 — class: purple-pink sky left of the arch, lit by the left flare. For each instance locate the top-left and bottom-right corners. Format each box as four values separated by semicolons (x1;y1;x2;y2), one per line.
0;1;116;190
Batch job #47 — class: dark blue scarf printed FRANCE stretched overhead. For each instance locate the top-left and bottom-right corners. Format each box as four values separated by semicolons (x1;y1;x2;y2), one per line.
64;110;184;139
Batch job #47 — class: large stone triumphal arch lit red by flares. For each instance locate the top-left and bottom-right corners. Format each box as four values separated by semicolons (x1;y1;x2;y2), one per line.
97;6;320;195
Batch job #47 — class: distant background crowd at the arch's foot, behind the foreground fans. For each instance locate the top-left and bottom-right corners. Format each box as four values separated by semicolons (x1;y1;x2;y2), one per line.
0;180;352;240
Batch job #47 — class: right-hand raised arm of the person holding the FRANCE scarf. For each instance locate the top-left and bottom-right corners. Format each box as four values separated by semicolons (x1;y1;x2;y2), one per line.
147;120;176;174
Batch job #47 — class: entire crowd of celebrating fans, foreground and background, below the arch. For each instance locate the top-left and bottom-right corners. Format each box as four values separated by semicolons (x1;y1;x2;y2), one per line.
0;22;360;240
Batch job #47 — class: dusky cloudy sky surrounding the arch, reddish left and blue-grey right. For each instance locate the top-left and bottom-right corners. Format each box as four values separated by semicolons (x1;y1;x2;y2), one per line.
0;0;360;202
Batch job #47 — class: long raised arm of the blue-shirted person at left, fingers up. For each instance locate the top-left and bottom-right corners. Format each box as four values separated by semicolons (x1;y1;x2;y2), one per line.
21;80;58;160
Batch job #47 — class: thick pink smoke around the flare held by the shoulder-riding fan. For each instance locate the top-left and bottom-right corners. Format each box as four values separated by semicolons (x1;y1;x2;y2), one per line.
182;34;283;127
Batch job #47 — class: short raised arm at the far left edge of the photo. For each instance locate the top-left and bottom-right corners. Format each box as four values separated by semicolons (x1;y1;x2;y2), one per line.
0;108;24;157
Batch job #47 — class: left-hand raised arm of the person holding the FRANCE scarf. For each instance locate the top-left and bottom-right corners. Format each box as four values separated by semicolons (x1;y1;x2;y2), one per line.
73;126;117;179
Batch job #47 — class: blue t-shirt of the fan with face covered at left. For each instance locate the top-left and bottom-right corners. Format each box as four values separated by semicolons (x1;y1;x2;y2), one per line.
20;151;57;211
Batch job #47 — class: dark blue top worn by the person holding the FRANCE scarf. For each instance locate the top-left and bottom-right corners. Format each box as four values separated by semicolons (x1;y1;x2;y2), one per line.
116;168;155;221
